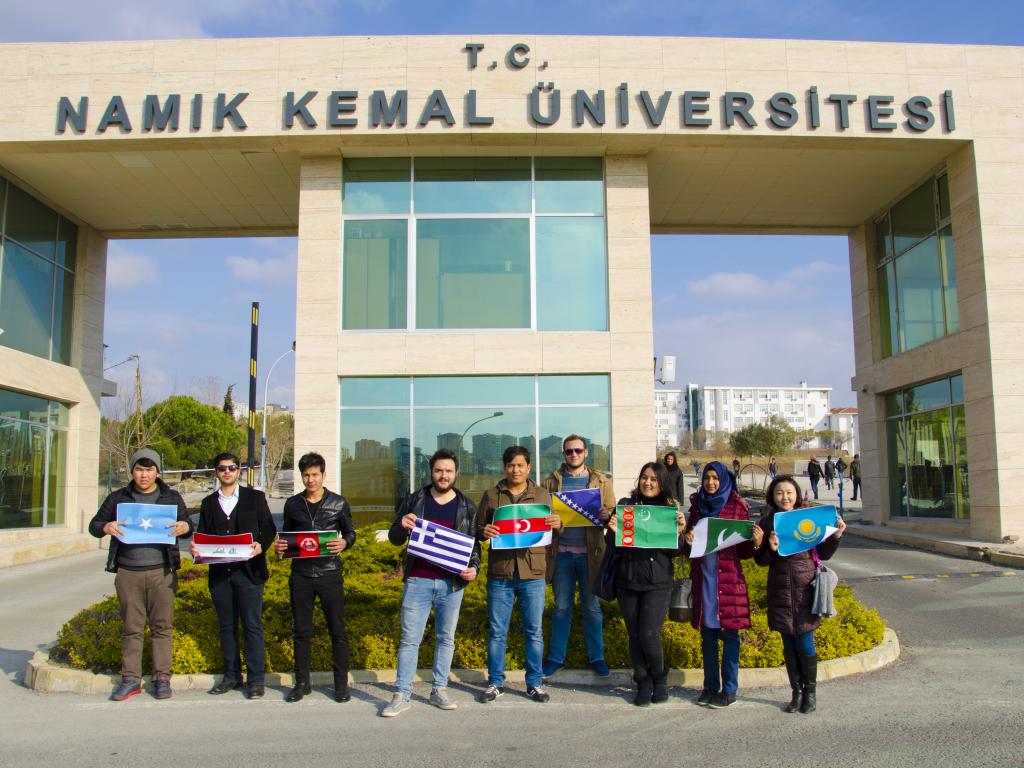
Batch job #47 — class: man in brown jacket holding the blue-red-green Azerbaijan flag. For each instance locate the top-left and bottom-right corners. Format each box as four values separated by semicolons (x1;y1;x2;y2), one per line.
477;445;562;703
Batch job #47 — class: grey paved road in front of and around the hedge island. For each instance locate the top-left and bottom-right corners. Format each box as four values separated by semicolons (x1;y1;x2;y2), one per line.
0;538;1024;768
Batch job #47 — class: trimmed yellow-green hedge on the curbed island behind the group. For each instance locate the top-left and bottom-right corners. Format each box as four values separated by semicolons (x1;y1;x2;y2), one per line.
50;526;885;674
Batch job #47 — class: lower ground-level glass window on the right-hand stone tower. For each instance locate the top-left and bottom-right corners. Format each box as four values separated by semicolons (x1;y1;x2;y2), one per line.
886;374;971;519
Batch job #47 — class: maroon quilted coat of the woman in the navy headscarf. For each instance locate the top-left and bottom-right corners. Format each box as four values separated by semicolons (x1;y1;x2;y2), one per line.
686;490;754;630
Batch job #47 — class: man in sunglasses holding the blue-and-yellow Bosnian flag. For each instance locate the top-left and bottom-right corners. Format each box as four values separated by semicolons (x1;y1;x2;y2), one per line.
544;434;615;677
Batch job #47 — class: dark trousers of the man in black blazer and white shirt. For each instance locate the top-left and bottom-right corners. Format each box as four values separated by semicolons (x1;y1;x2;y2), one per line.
209;564;266;685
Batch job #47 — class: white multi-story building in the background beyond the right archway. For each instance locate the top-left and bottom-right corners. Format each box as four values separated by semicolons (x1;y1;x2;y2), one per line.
685;381;831;447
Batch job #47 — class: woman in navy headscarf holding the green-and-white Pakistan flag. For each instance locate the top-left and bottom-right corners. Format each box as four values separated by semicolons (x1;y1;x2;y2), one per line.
684;462;761;709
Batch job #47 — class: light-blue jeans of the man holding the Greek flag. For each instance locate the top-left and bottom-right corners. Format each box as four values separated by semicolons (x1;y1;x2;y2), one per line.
395;577;465;698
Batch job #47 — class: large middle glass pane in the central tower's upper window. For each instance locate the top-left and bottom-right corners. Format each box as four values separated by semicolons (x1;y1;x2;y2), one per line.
416;219;530;329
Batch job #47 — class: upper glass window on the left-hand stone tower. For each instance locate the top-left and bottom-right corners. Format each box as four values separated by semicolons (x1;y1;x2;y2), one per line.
0;178;78;364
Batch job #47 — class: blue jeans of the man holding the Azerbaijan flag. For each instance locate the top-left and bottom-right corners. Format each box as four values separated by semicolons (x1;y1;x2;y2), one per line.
487;575;544;688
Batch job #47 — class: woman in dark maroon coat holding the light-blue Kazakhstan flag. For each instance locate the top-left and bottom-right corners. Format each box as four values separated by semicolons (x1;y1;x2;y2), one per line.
754;475;846;714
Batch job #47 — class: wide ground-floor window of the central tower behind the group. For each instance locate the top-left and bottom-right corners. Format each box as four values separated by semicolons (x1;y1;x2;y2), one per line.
340;376;611;524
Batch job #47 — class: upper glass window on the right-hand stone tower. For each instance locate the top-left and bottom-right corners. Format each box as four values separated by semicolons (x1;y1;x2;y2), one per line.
874;172;959;357
